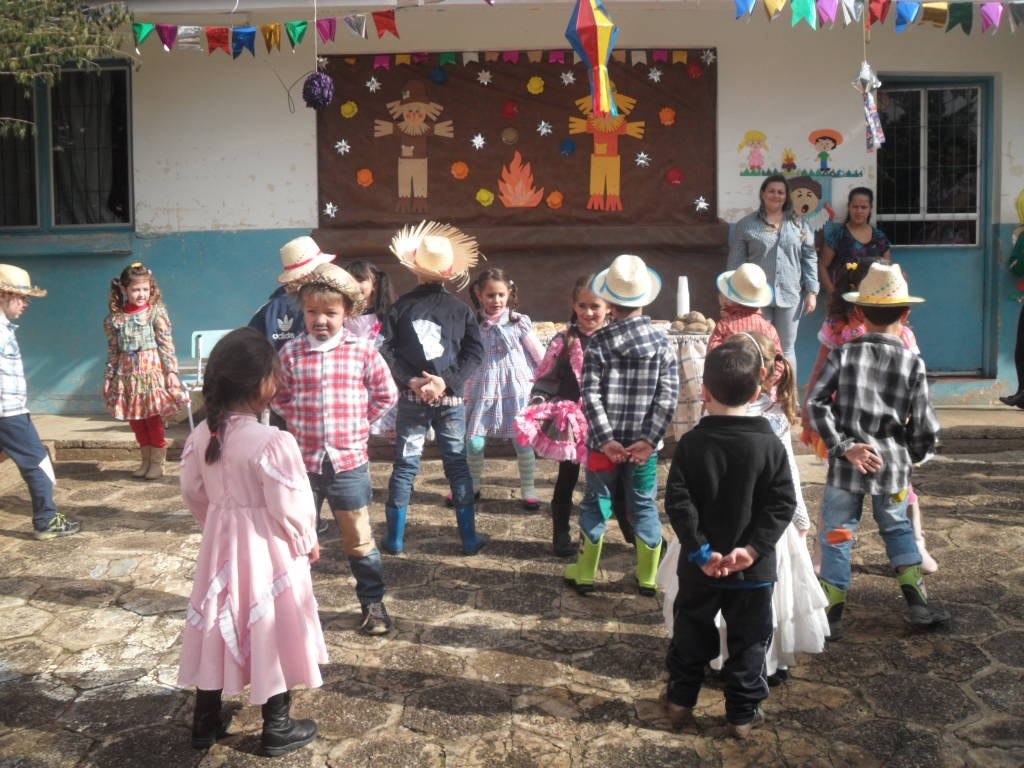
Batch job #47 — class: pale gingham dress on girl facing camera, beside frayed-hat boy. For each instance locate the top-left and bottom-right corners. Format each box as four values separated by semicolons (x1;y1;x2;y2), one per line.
463;310;544;439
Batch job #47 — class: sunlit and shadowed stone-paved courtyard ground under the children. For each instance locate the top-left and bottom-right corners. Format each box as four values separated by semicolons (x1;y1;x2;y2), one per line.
0;453;1024;768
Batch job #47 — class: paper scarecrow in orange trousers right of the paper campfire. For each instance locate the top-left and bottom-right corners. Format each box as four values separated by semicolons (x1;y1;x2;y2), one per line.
569;83;646;211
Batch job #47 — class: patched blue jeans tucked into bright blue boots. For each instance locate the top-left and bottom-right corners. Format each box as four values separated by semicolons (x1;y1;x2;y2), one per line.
386;397;473;511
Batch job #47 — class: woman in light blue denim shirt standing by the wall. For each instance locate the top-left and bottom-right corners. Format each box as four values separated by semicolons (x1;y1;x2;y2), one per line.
728;174;818;368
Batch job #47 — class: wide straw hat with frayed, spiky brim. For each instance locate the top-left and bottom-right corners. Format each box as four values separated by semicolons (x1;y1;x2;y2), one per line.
391;221;481;290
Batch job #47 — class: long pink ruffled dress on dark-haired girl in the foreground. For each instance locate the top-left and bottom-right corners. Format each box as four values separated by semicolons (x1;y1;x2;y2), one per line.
178;414;327;705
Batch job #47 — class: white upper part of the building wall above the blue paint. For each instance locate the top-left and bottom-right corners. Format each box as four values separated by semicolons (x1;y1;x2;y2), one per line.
133;0;1024;233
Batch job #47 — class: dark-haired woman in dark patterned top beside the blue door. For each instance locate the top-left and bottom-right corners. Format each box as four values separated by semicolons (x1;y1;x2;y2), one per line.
818;186;892;293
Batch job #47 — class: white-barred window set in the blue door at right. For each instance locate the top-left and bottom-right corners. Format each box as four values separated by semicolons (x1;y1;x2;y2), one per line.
877;84;983;246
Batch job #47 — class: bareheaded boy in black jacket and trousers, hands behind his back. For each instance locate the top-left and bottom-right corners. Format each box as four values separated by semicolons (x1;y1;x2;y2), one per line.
665;342;796;738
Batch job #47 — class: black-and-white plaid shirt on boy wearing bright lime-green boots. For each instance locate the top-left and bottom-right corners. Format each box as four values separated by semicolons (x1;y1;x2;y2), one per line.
580;315;679;451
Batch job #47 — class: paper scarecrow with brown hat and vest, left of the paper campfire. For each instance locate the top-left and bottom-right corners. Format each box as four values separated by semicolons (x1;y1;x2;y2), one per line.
374;80;455;213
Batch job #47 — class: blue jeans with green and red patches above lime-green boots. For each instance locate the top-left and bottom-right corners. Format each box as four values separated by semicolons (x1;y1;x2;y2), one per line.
580;454;662;548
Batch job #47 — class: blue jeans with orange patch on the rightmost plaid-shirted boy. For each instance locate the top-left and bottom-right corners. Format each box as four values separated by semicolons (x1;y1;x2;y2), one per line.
818;485;921;590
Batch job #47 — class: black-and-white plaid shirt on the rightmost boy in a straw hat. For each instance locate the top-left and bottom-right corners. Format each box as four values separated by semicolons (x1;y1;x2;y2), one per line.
807;333;939;495
